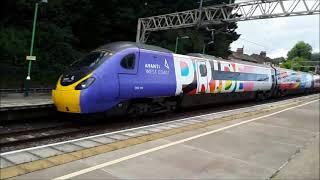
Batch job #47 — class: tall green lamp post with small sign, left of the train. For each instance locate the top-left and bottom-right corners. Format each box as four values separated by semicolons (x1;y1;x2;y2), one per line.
24;0;48;96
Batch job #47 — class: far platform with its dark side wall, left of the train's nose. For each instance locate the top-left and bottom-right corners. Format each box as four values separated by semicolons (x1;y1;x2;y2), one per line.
0;93;53;121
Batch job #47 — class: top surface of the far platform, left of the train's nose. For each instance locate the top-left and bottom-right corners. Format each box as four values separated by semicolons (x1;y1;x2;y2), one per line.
0;93;53;111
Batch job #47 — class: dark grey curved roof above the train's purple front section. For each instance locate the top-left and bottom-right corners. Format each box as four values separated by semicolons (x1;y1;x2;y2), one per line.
96;41;172;53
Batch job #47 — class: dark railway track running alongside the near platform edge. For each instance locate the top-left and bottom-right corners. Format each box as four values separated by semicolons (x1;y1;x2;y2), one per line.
0;93;316;152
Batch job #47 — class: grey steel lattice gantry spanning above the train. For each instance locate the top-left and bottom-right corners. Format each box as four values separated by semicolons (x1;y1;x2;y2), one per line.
136;0;320;43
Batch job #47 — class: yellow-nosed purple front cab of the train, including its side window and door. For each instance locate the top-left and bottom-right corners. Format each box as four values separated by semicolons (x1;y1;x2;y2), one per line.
52;47;145;114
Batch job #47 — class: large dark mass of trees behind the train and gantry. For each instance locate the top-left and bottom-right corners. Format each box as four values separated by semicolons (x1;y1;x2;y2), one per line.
0;0;239;88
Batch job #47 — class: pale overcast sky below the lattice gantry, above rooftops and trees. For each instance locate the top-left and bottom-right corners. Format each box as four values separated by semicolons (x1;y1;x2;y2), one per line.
231;3;320;58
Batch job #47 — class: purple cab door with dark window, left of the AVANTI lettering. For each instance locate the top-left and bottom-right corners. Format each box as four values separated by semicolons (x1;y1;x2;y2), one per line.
118;51;140;99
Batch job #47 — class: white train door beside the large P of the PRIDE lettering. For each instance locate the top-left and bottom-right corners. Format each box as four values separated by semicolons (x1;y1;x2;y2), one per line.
195;60;208;93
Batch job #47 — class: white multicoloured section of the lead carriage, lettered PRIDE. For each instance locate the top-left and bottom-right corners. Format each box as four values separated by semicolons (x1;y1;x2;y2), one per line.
174;54;275;106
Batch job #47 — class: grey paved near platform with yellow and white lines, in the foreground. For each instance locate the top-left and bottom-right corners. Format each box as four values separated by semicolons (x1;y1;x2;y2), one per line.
0;94;320;179
